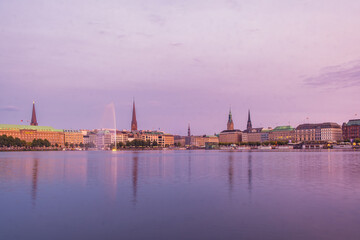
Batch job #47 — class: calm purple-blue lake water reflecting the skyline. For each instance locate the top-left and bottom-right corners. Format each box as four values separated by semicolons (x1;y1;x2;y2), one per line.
0;150;360;240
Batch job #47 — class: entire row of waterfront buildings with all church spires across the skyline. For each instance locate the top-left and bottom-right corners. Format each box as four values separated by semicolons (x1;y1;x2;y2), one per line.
0;102;360;149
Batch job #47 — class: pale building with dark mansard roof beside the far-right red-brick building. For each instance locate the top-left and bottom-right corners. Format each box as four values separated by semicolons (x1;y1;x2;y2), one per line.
295;122;342;142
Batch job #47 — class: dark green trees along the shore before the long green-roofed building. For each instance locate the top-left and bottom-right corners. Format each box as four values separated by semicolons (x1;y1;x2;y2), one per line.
0;135;54;148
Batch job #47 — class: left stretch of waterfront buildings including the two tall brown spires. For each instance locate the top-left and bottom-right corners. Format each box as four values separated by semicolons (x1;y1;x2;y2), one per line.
0;102;174;149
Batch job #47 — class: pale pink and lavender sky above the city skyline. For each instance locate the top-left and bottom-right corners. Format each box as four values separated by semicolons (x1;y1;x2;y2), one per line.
0;0;360;135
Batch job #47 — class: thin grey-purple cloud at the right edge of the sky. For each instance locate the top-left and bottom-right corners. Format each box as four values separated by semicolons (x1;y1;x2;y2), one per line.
304;60;360;88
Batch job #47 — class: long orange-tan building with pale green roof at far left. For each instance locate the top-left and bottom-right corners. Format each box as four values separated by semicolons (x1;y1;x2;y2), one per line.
0;124;64;146
